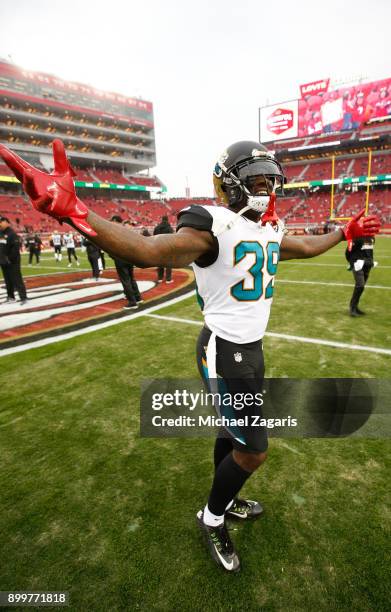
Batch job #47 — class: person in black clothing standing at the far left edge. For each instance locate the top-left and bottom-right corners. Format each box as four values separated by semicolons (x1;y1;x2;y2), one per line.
0;217;27;306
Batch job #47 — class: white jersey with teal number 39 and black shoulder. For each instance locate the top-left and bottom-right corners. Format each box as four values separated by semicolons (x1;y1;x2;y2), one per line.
178;206;284;344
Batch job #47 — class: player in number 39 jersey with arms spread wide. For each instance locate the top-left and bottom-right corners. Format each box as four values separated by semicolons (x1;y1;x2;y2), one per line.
0;140;380;572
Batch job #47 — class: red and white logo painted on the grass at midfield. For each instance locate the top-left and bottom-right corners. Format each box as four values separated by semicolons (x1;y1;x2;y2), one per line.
0;269;193;351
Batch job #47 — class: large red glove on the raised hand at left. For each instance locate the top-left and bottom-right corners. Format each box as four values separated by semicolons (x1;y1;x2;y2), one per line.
0;139;97;236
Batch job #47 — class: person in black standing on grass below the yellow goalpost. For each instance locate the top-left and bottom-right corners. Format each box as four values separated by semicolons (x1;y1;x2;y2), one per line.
345;238;375;317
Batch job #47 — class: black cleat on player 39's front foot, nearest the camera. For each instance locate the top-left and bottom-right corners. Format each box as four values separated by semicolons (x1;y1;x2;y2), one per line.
197;510;240;572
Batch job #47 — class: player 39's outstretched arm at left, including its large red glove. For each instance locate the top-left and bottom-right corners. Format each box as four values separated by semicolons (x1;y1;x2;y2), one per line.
0;139;213;267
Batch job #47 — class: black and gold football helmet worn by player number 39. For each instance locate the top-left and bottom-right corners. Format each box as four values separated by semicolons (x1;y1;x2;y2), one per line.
213;140;286;213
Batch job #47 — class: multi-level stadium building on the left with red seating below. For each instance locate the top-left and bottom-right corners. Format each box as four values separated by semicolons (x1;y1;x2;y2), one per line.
0;60;176;232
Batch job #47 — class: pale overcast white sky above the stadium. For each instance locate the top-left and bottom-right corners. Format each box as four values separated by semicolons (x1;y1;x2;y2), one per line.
0;0;391;196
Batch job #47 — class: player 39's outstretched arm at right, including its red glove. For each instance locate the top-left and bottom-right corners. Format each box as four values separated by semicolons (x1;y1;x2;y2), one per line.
280;208;380;260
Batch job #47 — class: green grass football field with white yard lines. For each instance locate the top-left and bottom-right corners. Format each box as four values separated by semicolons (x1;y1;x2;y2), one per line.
0;237;391;612
